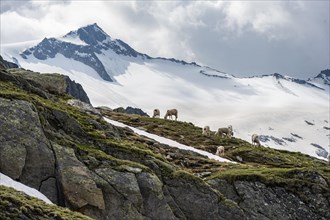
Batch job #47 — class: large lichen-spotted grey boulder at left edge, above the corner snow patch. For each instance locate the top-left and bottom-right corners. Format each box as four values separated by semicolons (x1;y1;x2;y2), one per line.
0;98;57;198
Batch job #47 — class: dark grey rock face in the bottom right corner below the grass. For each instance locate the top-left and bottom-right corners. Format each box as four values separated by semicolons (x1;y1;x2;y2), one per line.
209;179;330;220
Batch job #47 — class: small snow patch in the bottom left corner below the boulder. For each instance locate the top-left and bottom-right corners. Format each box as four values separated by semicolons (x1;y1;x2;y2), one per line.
0;173;53;204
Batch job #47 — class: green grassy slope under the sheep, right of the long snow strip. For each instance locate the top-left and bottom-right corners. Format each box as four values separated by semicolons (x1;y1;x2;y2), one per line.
103;111;330;194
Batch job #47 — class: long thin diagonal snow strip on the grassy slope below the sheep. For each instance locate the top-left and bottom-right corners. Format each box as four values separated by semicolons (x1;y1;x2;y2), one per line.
104;118;235;163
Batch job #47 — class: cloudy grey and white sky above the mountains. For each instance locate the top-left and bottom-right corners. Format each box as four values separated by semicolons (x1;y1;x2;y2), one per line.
0;0;330;78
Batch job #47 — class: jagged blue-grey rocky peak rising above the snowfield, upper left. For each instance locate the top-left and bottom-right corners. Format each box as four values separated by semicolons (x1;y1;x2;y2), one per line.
21;23;150;82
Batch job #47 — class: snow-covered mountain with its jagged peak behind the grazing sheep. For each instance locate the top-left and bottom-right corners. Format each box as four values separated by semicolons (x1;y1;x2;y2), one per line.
2;24;330;159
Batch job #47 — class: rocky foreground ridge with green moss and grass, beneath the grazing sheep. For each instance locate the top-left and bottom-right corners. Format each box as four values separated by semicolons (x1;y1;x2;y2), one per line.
0;62;330;219
